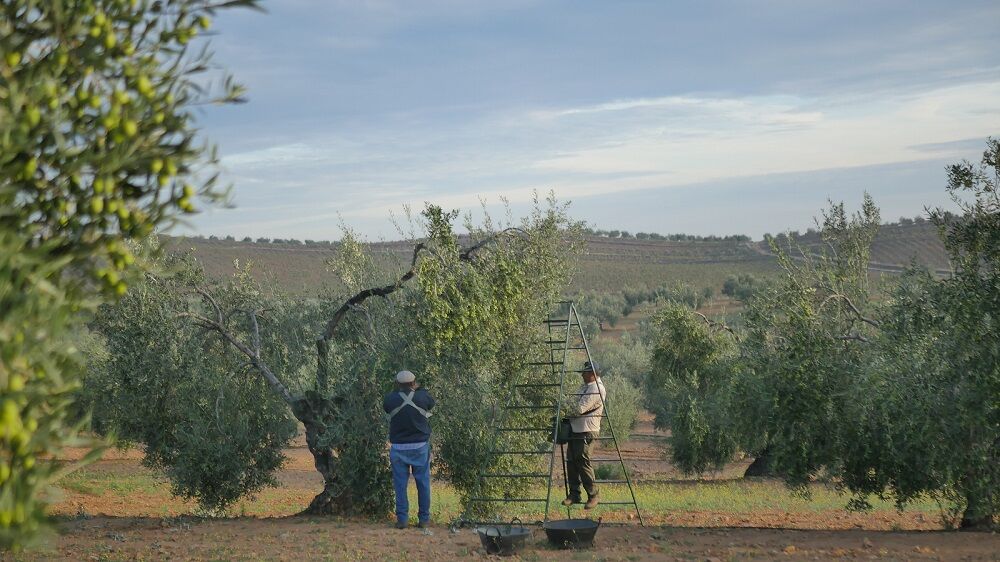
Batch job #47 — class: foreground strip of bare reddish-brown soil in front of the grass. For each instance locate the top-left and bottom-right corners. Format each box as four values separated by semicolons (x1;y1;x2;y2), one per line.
11;517;1000;560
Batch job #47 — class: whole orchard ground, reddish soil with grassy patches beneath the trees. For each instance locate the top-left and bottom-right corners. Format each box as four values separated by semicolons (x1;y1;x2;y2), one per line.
11;415;1000;561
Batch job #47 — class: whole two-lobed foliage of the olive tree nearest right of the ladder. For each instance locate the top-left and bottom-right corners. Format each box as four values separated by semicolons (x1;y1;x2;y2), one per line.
647;196;879;476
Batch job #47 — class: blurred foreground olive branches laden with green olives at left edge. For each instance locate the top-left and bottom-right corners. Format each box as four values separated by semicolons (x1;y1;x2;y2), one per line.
0;0;255;548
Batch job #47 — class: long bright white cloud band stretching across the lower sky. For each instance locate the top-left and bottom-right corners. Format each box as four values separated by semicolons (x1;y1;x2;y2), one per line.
193;77;1000;238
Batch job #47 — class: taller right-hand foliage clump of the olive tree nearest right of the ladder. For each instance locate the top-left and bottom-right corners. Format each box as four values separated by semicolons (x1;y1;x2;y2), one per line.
735;194;880;486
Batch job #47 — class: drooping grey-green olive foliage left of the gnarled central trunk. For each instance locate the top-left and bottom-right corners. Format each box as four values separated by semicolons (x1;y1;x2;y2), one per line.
84;247;306;511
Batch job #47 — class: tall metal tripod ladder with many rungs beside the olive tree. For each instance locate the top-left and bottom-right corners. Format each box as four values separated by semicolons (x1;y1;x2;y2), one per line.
459;301;644;525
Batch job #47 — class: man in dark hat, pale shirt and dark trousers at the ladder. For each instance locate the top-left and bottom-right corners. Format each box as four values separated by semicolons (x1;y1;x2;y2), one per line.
563;361;607;509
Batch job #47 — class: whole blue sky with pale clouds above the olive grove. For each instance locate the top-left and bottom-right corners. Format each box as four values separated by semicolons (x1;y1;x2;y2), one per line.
189;0;1000;240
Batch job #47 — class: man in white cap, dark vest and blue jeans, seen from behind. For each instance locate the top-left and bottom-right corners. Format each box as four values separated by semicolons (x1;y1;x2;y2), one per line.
382;371;434;529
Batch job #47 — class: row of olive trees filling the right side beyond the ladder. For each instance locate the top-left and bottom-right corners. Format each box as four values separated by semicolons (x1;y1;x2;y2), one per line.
647;139;1000;528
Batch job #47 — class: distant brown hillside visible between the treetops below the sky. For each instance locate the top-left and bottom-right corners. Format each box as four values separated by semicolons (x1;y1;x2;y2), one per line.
164;223;948;295
